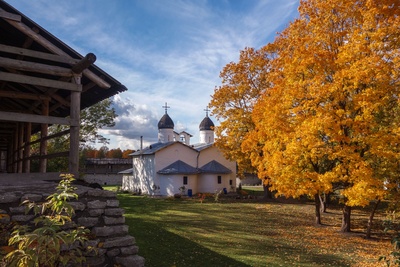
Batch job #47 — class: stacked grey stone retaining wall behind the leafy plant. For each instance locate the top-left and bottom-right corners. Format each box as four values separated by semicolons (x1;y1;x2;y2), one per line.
0;181;144;267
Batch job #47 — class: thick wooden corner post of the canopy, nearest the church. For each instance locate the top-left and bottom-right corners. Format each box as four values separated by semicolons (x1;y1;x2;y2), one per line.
69;75;81;178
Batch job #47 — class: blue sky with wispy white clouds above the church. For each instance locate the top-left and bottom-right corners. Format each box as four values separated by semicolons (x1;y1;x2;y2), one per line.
6;0;299;150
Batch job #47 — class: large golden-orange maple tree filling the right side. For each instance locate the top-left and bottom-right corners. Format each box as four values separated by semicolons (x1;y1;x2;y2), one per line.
242;0;400;232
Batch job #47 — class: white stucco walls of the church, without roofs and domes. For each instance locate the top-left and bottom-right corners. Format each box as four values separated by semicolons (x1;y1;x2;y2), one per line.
122;142;236;196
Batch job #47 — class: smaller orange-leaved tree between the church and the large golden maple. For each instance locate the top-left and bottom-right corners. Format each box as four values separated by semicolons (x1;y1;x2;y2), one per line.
209;48;276;198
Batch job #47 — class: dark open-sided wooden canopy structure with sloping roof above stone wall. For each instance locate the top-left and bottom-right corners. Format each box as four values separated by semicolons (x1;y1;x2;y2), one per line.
0;0;127;178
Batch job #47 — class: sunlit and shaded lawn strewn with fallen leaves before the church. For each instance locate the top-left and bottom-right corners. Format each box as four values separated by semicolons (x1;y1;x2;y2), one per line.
111;188;390;267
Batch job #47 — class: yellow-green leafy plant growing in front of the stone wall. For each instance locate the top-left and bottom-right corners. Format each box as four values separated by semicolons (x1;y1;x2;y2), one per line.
3;174;91;267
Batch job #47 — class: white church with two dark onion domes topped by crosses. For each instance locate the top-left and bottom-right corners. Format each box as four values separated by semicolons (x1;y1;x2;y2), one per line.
121;104;236;196
